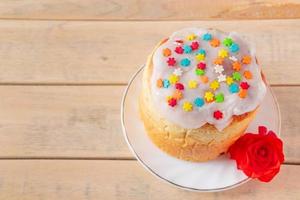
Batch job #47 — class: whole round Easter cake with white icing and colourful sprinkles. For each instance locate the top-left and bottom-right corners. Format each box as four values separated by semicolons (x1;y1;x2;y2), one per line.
139;28;266;162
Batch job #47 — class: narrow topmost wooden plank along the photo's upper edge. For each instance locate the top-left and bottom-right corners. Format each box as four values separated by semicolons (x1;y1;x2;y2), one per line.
0;0;300;20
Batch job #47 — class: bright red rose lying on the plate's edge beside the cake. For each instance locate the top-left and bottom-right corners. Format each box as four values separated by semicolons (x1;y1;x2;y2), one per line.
228;126;284;182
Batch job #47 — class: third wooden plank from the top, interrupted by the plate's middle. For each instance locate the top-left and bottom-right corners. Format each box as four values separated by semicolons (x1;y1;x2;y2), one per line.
0;86;300;163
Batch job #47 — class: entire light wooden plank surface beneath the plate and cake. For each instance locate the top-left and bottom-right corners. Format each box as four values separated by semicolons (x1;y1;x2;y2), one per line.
0;0;300;200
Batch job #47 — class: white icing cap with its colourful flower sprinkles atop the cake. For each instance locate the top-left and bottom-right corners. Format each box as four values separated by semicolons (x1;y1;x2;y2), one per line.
151;28;266;131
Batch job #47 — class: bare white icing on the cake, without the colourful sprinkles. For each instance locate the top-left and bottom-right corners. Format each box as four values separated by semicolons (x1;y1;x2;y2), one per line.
151;28;266;131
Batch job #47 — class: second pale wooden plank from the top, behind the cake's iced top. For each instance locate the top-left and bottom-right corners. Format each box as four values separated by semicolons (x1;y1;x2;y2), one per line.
0;19;300;84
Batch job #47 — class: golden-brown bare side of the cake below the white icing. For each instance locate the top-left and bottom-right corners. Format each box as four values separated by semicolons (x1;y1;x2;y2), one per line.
139;39;257;162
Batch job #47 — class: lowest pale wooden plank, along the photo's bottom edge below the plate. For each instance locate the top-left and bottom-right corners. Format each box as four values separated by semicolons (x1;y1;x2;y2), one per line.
0;160;300;200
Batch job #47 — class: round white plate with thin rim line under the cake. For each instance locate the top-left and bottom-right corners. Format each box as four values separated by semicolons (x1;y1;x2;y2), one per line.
121;66;280;192
